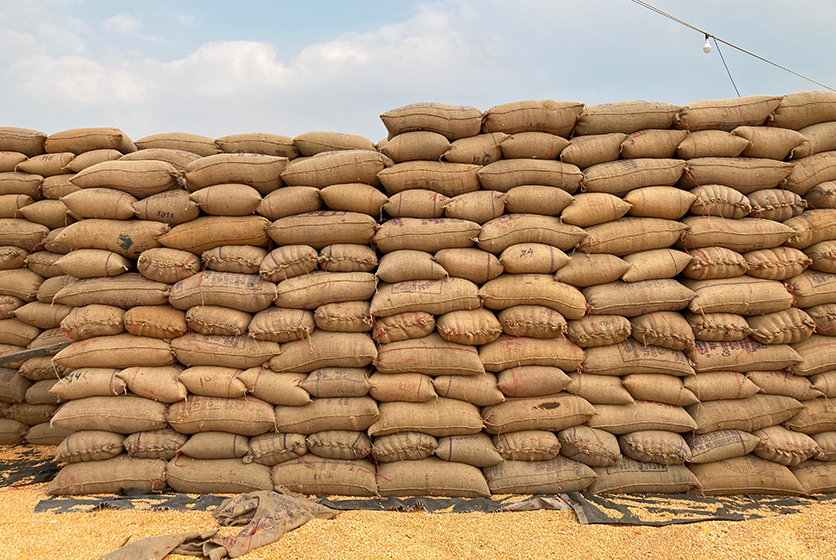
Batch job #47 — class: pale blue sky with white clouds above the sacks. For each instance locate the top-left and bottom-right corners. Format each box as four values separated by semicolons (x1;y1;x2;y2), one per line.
0;0;836;141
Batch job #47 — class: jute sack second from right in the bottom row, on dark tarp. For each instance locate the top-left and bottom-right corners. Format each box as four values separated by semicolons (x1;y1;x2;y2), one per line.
691;455;804;496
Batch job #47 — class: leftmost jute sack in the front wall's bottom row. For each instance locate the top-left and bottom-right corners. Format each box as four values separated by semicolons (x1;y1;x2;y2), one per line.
46;456;166;496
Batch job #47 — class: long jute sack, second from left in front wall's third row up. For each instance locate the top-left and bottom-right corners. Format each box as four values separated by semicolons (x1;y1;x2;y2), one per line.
167;396;276;436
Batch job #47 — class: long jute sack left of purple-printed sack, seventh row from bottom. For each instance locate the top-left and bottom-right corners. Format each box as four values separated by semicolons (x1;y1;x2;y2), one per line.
52;273;170;309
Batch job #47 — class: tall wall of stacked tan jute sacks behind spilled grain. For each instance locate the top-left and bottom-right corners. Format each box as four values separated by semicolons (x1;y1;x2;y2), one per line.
0;92;836;496
